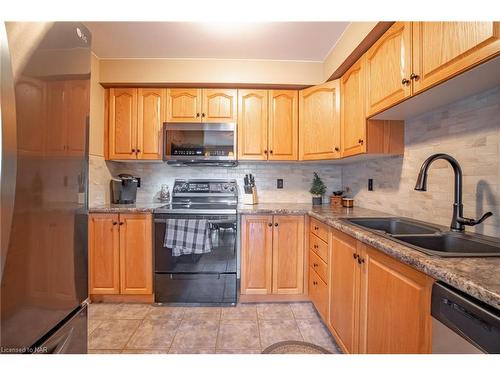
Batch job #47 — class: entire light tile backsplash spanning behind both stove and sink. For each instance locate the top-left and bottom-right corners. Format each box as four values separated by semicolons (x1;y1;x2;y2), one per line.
90;87;500;237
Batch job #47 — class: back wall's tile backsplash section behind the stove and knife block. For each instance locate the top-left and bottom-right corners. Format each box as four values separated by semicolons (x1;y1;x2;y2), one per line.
90;159;342;206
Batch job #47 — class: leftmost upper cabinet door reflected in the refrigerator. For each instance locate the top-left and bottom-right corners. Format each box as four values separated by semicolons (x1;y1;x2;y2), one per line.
15;77;47;155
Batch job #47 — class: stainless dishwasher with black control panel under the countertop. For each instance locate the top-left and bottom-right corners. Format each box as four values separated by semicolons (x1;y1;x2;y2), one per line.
431;282;500;354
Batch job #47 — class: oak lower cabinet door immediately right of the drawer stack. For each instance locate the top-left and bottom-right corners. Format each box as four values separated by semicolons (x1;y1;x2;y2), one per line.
328;231;360;353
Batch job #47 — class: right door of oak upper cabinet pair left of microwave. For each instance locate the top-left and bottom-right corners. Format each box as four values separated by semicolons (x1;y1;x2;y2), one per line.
137;89;166;160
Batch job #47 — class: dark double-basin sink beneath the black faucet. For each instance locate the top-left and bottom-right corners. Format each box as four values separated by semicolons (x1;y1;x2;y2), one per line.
344;217;500;257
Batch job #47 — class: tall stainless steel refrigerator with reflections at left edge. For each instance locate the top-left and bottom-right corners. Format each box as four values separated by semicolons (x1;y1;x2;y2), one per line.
0;22;91;353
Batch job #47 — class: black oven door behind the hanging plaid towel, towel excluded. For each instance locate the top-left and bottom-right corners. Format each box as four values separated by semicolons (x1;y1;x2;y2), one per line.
154;214;237;274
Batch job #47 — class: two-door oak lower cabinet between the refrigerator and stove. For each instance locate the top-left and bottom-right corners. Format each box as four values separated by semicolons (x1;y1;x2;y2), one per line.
89;213;153;295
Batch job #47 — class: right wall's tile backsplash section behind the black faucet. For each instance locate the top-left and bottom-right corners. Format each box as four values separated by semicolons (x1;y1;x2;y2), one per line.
342;87;500;237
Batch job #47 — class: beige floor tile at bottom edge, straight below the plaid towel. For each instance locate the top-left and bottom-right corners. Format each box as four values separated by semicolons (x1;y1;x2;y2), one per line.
172;320;219;349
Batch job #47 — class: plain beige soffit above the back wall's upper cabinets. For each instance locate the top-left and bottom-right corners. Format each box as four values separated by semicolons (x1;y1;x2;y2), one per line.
100;59;324;85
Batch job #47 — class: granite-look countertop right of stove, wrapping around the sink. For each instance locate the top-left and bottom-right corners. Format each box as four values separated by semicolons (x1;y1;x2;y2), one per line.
238;203;500;309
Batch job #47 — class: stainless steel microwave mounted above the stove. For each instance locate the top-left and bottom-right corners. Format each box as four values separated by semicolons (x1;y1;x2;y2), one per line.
163;122;236;165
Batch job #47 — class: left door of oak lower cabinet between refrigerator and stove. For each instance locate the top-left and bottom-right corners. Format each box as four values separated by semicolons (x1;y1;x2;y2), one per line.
89;214;120;294
